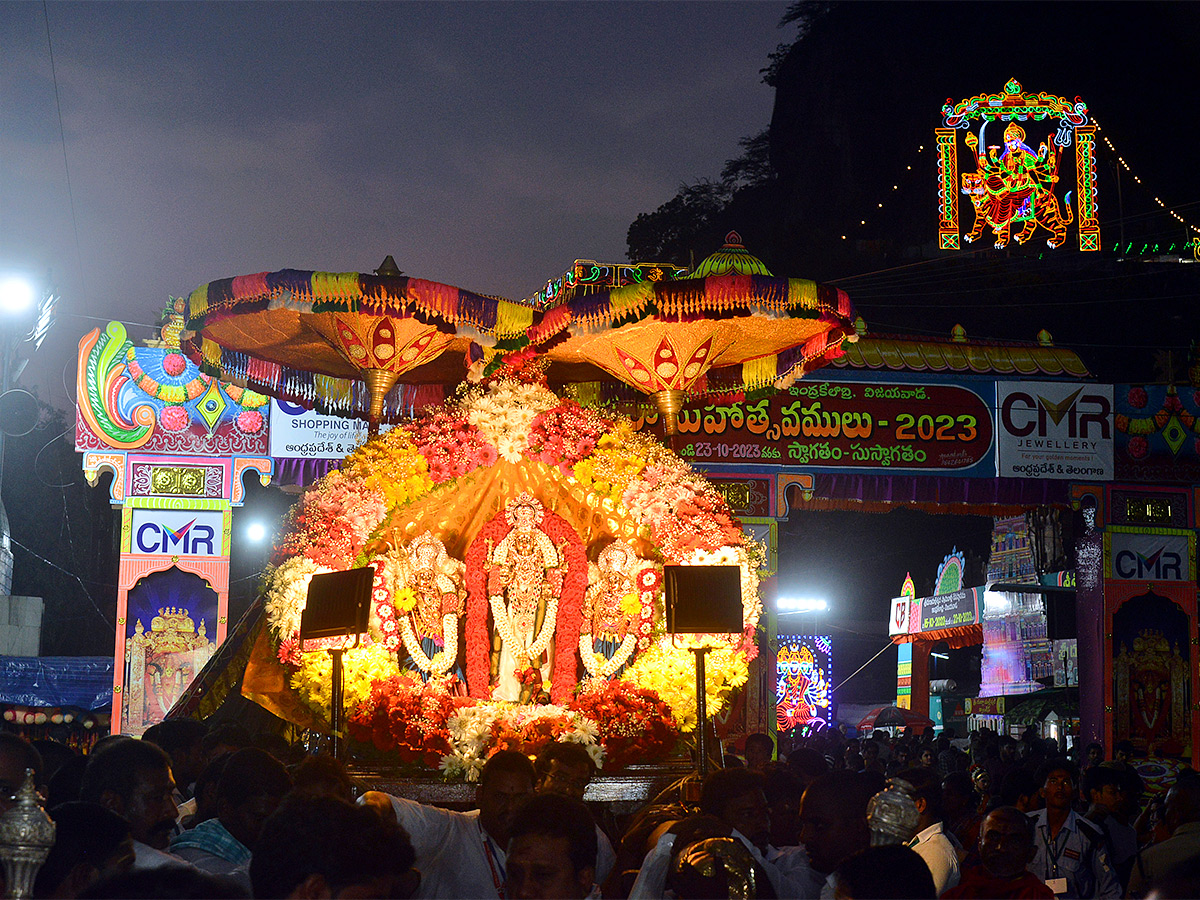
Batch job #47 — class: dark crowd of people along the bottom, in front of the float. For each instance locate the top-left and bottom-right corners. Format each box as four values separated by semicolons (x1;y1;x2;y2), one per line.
0;720;1200;900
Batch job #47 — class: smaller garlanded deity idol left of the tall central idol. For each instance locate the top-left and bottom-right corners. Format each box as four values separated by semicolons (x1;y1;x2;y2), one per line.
398;532;466;680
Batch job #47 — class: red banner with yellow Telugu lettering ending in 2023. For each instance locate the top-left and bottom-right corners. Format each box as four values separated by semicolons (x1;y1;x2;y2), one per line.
657;382;995;478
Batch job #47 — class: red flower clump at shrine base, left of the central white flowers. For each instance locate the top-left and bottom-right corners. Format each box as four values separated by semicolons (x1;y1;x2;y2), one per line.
346;676;457;768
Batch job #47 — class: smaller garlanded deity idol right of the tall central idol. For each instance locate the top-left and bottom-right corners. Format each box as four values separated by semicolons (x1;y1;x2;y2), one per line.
580;541;642;678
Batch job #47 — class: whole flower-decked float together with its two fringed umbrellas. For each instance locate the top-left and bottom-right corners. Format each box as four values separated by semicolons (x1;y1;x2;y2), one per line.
181;240;856;780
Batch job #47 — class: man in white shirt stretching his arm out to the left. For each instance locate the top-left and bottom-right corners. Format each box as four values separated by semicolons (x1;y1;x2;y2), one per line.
361;750;534;900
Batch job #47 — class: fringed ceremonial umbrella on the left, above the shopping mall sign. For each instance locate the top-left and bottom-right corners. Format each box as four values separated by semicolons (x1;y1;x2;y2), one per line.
180;257;533;431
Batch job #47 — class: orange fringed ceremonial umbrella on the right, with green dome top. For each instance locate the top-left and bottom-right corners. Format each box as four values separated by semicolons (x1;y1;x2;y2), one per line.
528;232;857;434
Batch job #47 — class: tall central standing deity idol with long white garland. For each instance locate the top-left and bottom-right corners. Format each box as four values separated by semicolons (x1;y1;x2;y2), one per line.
487;492;566;701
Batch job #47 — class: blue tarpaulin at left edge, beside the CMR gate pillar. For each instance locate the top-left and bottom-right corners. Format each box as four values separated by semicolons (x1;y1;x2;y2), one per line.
0;656;113;712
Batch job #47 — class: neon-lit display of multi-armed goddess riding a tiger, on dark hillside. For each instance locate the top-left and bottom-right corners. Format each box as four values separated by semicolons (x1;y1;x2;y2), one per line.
935;79;1100;251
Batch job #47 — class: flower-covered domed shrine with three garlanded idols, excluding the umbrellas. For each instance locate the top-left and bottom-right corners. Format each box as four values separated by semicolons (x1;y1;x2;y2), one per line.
256;377;762;779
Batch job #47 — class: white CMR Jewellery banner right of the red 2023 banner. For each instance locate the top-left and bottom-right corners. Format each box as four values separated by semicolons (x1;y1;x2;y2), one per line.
996;382;1114;481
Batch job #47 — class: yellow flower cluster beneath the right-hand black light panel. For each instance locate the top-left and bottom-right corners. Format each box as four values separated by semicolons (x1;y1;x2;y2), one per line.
622;640;750;732
